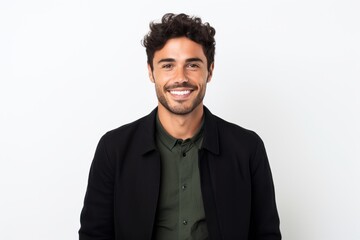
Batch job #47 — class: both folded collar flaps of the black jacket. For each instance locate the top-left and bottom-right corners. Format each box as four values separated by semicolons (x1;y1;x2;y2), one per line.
139;106;219;155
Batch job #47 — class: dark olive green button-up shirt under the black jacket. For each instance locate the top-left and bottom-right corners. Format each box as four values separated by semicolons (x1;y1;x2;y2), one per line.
154;117;208;240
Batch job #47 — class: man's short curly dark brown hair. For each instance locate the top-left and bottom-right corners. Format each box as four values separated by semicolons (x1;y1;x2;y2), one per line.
142;13;215;70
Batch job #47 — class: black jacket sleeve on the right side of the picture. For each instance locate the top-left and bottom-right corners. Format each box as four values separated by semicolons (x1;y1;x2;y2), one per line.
249;137;281;240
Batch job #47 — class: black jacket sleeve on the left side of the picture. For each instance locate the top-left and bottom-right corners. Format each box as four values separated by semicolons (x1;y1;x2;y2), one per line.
79;135;115;240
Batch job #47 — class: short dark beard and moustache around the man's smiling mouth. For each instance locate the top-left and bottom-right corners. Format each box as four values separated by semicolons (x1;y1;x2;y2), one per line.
155;82;205;115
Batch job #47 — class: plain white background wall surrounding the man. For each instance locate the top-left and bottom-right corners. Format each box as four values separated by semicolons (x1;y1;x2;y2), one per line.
0;0;360;240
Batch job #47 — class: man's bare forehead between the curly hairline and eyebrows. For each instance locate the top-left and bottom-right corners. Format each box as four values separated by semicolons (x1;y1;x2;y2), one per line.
154;37;206;62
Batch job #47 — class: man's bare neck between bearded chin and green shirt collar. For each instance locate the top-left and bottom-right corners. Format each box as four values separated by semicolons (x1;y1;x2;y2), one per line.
158;104;204;140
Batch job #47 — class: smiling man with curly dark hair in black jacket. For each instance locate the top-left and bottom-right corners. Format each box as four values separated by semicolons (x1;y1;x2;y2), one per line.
79;14;281;240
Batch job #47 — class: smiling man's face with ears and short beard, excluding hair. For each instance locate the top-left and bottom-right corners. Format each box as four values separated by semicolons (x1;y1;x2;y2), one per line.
148;37;214;115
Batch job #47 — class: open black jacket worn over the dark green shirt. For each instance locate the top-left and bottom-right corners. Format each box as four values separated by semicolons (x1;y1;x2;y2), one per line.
79;107;281;240
